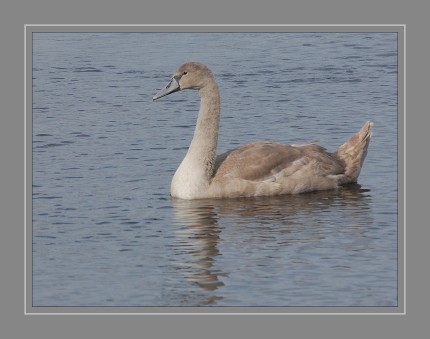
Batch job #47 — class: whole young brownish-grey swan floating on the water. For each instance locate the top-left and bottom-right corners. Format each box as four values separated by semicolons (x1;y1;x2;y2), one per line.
153;62;373;199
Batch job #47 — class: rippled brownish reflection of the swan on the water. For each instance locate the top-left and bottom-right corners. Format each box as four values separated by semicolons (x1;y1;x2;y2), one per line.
171;184;371;304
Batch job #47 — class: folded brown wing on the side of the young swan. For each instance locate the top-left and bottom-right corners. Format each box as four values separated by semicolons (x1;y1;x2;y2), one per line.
214;142;344;181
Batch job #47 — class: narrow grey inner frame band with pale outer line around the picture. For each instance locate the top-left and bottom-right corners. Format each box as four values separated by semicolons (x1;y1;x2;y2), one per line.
24;25;406;315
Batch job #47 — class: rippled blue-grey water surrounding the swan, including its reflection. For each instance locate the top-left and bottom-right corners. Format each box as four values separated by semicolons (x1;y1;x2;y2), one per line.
32;33;398;306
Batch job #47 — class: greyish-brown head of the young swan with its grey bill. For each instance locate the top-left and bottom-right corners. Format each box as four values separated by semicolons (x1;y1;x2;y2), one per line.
152;62;213;100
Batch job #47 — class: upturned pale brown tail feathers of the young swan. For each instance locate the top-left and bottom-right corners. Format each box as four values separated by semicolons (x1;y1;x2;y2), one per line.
334;121;373;184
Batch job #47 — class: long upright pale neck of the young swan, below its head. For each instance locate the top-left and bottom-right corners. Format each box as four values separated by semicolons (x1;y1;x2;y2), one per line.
171;80;220;199
